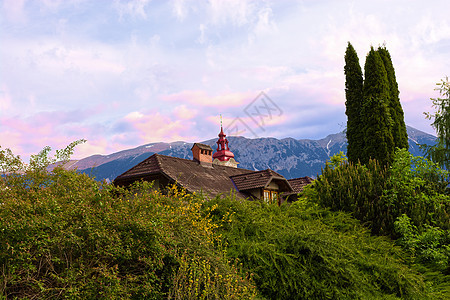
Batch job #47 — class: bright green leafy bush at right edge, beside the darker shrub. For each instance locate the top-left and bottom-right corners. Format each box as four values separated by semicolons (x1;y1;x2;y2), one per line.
383;150;450;276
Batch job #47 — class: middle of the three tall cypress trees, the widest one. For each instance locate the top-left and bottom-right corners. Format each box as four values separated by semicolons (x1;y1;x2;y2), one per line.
361;47;395;164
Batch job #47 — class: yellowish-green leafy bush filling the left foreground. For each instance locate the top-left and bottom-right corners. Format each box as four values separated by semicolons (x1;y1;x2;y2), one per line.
0;148;255;299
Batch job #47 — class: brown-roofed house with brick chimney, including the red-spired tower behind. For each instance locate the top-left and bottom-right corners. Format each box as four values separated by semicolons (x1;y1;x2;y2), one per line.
113;127;312;204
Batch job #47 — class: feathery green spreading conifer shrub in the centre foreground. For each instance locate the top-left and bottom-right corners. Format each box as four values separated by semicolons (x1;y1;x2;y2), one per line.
205;199;432;299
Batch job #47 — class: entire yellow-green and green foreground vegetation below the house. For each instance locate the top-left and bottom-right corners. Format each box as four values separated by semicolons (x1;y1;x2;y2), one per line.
0;145;448;299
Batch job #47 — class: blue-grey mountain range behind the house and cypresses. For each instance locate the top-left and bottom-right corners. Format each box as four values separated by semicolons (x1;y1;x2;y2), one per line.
70;126;436;181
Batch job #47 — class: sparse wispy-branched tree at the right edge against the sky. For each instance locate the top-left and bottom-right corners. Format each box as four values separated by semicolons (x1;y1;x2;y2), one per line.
421;77;450;170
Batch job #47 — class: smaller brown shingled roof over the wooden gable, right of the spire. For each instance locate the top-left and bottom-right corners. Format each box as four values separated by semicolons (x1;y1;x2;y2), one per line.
231;169;293;191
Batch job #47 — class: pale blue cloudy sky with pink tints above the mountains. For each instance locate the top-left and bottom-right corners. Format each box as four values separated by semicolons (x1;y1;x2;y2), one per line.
0;0;450;158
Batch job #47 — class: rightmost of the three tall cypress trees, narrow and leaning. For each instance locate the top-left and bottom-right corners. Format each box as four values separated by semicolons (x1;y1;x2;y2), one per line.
377;46;409;149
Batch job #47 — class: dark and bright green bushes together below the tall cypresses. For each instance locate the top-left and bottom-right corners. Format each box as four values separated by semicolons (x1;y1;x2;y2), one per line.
312;149;450;288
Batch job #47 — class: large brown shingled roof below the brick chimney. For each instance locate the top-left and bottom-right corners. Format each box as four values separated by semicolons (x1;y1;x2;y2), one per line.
114;154;255;198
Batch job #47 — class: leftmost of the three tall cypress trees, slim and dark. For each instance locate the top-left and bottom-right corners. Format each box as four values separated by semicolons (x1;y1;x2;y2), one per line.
344;42;364;163
